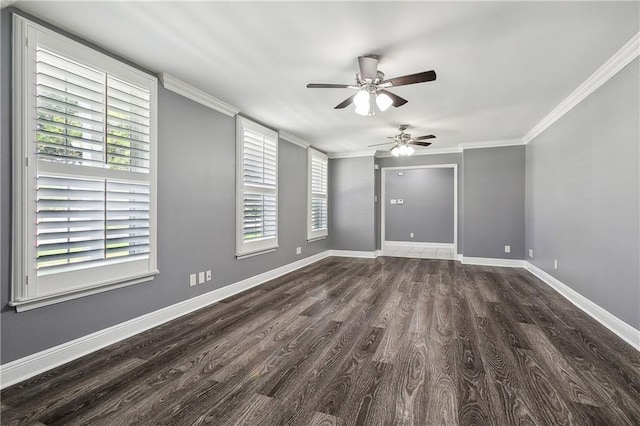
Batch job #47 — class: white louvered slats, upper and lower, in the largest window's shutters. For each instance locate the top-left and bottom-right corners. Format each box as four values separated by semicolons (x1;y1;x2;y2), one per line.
36;46;151;275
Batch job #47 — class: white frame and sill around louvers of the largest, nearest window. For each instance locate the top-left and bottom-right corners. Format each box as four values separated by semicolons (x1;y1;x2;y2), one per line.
9;14;158;312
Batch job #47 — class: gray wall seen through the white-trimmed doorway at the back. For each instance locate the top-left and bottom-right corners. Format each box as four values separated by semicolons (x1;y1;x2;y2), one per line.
382;168;454;244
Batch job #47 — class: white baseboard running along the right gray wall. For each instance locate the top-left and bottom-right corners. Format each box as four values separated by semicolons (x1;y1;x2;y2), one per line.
525;262;640;351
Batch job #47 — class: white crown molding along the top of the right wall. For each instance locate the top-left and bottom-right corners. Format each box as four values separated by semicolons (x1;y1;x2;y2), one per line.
522;33;640;144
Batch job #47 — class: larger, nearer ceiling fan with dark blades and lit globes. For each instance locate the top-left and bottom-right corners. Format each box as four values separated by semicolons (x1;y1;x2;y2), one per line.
307;55;436;115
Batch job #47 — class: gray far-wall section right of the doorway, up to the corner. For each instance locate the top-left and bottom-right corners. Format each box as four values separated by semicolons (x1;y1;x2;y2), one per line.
462;146;525;259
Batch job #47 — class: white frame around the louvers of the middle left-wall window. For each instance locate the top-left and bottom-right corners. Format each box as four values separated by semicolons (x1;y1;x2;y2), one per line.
236;115;280;259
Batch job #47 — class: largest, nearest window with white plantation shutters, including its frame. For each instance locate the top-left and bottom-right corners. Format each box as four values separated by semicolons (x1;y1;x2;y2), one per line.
11;16;157;310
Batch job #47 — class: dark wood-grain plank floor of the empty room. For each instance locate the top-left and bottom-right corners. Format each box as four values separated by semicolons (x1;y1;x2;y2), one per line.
1;257;640;426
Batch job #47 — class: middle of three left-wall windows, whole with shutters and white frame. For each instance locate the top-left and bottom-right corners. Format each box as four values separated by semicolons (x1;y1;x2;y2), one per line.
236;116;278;258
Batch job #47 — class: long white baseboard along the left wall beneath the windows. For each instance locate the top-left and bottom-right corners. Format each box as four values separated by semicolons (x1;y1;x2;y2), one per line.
0;250;330;388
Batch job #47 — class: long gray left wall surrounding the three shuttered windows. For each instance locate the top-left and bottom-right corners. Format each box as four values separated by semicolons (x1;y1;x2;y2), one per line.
0;11;330;364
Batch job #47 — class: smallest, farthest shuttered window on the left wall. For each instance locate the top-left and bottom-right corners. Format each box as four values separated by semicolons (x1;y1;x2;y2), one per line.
307;148;329;241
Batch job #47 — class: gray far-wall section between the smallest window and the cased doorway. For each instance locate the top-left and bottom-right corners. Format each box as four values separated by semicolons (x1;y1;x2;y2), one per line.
329;157;375;251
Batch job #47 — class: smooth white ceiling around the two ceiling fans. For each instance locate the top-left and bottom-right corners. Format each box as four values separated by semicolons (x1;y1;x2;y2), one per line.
10;1;640;152
